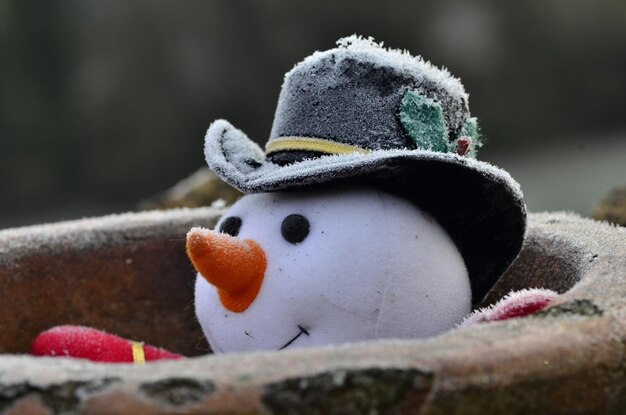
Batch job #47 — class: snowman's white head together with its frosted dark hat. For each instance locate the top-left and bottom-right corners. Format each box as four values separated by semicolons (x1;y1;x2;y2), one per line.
187;36;526;352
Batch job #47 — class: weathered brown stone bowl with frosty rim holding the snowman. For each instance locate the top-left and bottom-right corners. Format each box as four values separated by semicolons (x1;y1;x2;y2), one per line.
0;208;626;414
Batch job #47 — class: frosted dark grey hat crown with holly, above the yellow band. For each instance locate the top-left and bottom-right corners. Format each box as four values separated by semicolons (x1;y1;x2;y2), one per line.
270;36;479;159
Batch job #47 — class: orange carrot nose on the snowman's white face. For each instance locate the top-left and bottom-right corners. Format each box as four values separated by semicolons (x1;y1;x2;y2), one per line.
187;228;267;313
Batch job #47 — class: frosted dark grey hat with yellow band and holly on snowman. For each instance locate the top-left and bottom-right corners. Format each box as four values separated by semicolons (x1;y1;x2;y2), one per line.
205;36;526;304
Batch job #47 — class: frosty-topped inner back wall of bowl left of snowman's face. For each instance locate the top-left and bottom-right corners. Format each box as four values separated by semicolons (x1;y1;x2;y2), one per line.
0;208;221;356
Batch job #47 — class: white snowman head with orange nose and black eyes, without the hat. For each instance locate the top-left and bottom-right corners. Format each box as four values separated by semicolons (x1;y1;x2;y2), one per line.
187;188;471;352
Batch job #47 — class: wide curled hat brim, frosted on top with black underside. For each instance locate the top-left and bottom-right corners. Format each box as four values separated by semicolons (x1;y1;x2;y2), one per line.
205;120;526;304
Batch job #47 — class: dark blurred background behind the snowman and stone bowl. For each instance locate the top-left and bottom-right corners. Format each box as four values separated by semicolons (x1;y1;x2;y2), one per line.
0;0;626;228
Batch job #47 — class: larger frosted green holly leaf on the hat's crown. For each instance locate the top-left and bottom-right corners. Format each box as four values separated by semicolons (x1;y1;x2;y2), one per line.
400;91;451;153
